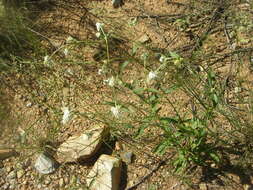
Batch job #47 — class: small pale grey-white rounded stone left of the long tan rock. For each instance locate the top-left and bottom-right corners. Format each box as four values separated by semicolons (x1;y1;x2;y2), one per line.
34;153;56;174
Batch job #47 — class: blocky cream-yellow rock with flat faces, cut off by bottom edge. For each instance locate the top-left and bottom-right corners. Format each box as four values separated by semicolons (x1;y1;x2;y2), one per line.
86;154;121;190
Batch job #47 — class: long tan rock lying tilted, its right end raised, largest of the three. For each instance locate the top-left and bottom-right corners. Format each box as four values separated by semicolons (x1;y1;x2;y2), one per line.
57;125;109;162
